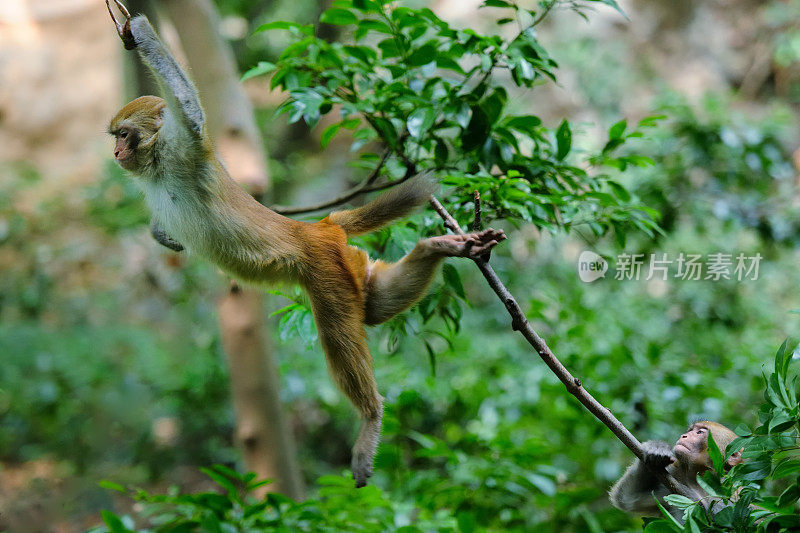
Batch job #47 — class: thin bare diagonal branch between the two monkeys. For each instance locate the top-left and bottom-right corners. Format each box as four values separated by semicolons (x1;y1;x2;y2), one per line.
430;195;697;499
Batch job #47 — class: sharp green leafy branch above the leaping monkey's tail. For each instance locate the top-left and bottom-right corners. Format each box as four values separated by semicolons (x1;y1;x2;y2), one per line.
252;0;657;241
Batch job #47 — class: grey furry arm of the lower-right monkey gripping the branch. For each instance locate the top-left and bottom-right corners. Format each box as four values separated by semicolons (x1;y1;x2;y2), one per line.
609;440;673;515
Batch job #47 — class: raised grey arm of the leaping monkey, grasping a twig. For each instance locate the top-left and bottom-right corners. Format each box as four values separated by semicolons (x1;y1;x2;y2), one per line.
106;0;205;138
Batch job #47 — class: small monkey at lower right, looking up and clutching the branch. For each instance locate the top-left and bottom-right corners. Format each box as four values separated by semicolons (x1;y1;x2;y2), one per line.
609;420;742;520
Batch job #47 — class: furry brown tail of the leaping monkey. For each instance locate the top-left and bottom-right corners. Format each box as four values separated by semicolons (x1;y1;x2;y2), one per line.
328;174;436;235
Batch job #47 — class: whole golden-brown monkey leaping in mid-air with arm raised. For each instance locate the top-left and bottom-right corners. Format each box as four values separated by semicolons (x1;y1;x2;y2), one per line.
106;0;505;487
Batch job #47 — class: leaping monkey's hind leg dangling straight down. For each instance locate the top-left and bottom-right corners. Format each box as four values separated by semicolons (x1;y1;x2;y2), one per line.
308;277;383;488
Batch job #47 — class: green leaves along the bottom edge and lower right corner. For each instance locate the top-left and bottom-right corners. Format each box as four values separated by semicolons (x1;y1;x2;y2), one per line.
93;343;800;533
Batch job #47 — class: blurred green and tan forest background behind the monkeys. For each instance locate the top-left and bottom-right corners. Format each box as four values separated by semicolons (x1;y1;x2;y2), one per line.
0;0;800;531
